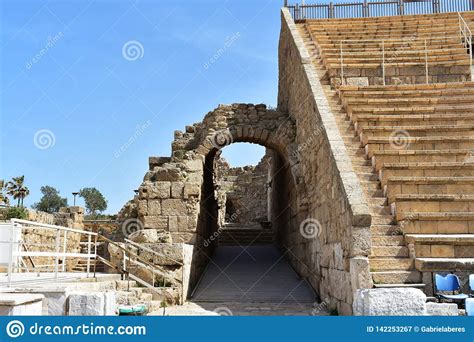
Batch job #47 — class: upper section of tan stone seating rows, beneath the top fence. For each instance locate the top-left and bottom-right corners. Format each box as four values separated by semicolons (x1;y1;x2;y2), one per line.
303;12;474;87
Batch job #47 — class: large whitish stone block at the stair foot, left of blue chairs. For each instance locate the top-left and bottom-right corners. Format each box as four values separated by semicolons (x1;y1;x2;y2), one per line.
353;288;426;316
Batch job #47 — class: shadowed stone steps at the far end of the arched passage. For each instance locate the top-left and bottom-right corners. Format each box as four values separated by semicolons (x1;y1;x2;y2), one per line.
218;223;274;246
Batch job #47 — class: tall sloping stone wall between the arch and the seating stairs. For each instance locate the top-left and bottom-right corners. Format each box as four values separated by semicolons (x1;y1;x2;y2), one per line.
276;9;372;315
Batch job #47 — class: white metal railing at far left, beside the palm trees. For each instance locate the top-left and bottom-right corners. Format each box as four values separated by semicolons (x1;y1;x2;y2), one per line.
0;219;97;287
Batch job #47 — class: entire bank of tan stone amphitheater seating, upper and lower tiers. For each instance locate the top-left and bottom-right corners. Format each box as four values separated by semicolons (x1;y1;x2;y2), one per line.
299;12;474;293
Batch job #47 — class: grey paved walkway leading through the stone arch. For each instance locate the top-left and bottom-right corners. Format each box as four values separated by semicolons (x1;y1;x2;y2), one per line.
164;246;326;315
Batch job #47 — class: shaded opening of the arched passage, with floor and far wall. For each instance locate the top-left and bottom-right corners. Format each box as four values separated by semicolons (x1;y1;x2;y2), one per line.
192;145;315;306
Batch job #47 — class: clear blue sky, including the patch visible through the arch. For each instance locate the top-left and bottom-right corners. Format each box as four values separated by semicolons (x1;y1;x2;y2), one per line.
0;0;283;213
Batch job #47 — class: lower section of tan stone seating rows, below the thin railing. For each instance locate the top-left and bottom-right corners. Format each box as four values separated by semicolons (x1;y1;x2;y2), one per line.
339;82;474;281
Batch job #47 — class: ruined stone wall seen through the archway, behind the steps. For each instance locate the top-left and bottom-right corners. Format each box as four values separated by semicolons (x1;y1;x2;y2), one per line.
216;154;271;225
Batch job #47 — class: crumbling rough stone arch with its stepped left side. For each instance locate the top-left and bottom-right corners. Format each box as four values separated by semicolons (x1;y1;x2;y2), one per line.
119;104;304;296
